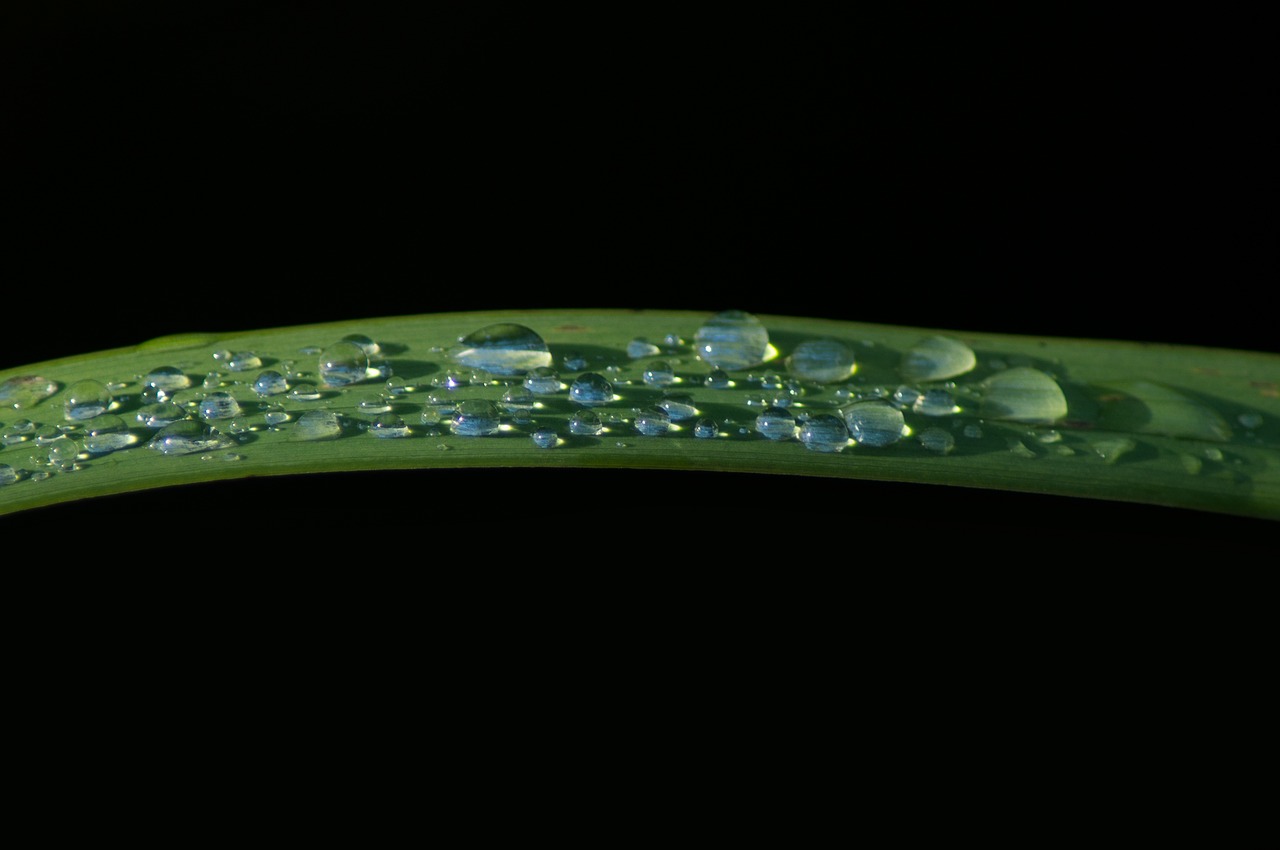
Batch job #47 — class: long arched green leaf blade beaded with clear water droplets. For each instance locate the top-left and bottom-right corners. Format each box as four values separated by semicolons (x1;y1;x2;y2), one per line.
0;310;1280;520
